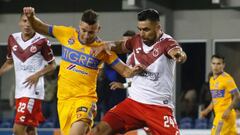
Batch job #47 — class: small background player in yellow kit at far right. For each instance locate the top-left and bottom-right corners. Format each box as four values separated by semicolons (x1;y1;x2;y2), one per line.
200;55;239;135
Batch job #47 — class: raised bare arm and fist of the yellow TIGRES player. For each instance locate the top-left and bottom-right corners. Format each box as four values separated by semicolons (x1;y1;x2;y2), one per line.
23;7;50;35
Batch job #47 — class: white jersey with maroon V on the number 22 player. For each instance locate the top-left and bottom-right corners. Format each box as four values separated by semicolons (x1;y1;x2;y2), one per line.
7;32;54;99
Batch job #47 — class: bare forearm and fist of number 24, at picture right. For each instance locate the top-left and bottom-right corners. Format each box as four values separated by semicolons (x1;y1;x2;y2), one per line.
168;48;187;63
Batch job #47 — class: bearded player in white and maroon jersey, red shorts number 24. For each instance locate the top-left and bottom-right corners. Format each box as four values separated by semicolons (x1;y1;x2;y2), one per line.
92;9;187;135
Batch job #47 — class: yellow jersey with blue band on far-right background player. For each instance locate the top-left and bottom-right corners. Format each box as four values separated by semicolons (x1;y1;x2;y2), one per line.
210;72;238;112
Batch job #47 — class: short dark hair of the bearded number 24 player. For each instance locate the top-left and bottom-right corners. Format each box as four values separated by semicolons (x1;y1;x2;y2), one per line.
138;8;160;21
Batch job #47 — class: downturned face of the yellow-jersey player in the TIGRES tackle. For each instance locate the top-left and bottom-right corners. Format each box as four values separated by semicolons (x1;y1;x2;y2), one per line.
79;21;100;44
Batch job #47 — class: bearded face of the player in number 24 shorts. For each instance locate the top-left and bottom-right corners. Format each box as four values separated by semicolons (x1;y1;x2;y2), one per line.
137;20;161;44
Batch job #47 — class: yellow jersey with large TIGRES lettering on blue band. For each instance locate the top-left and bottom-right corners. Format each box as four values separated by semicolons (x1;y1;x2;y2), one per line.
49;25;120;100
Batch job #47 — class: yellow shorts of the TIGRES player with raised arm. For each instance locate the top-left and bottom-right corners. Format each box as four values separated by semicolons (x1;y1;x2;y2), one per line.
58;98;97;135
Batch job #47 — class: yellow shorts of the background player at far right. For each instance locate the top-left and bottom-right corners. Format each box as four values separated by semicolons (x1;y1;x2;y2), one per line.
211;111;237;135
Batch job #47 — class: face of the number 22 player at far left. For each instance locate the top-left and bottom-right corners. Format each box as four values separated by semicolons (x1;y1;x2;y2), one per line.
18;15;34;35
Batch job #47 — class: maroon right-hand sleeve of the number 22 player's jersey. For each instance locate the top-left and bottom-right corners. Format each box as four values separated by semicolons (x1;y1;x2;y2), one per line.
41;39;55;63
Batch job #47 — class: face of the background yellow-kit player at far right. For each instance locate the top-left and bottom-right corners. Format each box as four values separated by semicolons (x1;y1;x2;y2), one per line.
211;58;225;75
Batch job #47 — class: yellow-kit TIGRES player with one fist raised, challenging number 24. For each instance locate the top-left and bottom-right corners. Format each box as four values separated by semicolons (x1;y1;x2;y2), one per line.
23;7;143;135
